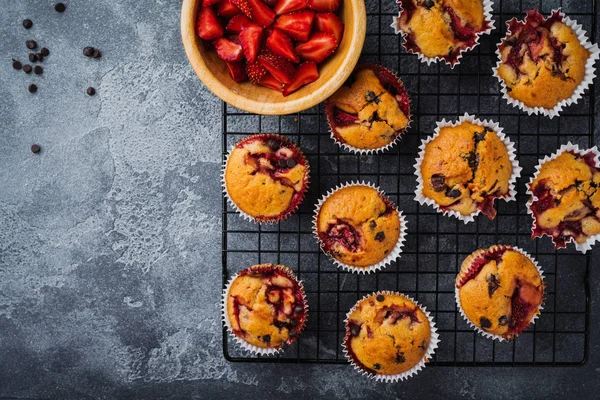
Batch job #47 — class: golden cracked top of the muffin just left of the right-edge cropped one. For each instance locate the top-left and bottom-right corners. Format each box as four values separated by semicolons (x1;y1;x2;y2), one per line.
419;121;513;219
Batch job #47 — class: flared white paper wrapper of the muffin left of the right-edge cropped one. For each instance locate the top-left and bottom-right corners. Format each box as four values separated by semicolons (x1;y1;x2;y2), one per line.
414;113;522;224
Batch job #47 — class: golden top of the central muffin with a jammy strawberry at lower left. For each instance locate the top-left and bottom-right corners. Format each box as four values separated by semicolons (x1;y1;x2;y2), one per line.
316;185;400;268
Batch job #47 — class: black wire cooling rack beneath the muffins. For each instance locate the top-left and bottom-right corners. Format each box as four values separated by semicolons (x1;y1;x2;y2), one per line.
222;0;596;366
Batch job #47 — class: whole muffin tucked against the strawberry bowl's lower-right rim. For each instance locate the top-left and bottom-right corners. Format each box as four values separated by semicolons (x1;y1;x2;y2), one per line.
325;64;411;153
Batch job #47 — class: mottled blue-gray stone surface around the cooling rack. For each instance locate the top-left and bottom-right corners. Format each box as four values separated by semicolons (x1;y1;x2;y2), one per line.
0;0;600;399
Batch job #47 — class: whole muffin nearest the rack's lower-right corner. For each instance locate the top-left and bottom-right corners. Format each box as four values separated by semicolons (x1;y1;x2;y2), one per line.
456;245;544;339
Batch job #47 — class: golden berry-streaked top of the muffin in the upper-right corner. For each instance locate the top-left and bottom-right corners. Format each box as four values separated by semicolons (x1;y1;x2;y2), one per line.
497;9;591;109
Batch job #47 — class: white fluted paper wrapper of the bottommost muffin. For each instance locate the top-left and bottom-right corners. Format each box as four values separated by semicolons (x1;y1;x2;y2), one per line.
342;290;440;382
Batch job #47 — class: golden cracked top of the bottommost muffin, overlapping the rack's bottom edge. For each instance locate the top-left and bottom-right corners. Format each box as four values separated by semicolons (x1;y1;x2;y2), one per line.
344;293;431;375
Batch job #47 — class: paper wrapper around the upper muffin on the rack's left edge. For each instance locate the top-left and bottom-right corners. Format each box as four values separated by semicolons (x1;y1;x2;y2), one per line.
221;133;310;224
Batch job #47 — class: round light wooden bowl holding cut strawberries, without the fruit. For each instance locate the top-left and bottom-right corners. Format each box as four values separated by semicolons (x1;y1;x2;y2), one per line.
181;0;367;115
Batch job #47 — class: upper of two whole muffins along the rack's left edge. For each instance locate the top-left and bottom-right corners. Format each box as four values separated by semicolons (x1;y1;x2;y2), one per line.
223;134;309;222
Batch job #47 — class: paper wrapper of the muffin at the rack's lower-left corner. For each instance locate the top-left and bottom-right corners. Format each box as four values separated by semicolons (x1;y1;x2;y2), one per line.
221;264;308;356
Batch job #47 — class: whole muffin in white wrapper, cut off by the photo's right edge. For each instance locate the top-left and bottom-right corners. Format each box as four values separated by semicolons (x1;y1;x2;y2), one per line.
527;143;600;252
